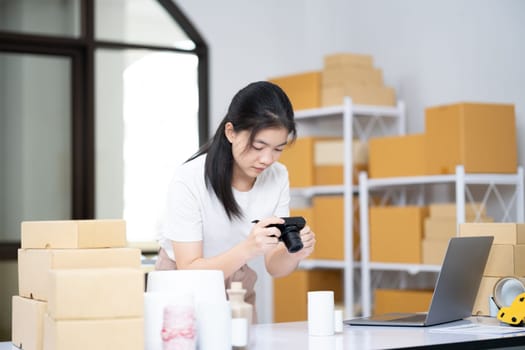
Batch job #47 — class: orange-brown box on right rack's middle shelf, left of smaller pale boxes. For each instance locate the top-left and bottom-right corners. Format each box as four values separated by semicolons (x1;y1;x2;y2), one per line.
370;206;428;264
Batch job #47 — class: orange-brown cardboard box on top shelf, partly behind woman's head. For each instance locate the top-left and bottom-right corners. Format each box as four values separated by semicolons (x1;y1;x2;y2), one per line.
269;71;321;111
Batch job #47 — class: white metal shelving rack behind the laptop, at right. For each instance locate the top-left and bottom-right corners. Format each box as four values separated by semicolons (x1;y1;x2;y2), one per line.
359;165;525;316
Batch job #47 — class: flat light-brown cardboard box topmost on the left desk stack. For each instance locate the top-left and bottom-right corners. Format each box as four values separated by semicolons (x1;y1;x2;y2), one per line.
21;220;127;249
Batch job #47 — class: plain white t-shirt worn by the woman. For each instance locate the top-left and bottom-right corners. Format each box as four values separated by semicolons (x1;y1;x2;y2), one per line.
159;155;290;260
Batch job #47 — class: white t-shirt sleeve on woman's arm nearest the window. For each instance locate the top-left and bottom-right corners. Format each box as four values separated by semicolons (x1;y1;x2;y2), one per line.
162;179;202;242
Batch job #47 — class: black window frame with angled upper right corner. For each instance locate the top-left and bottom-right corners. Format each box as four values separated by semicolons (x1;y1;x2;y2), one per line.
0;0;209;260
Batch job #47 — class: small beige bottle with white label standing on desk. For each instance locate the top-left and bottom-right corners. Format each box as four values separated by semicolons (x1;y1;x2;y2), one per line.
226;282;253;350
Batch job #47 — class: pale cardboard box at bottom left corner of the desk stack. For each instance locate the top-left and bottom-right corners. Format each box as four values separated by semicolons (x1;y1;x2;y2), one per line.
11;295;47;350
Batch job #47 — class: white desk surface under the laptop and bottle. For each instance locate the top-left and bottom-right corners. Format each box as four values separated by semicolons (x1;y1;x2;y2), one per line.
0;317;525;350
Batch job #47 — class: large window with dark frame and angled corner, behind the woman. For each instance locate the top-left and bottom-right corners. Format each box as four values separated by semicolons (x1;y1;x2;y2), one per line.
0;0;208;250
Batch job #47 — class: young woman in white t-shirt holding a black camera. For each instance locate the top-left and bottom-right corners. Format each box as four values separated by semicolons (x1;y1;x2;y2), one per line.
156;81;315;318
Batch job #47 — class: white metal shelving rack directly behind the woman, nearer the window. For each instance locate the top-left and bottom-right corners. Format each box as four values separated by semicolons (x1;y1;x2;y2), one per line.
291;97;406;317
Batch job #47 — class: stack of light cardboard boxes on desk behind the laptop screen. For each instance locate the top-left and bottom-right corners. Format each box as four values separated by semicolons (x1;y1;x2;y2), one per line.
459;222;525;316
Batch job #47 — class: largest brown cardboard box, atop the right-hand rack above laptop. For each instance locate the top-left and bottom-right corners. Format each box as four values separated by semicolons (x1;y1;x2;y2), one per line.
425;103;518;174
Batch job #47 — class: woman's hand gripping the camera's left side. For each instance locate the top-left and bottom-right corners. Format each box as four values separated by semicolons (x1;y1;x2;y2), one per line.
245;216;284;257
